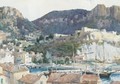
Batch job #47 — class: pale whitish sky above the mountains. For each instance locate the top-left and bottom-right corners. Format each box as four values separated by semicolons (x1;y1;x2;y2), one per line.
0;0;120;21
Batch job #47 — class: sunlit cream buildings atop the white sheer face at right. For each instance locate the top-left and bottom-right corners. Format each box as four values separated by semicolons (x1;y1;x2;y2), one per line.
75;27;120;42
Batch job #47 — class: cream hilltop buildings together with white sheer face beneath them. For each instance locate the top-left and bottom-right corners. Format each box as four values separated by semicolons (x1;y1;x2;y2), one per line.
75;27;120;62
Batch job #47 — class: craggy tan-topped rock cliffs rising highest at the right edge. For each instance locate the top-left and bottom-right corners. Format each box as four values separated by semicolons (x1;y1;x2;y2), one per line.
85;4;120;33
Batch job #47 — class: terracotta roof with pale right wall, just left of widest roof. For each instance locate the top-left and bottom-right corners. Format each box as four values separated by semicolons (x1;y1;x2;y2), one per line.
18;74;47;84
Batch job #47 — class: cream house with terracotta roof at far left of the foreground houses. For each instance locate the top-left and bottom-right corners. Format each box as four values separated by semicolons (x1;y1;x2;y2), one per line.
0;63;29;84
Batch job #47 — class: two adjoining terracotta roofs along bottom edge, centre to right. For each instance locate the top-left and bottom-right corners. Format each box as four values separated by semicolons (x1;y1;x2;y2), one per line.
47;73;102;84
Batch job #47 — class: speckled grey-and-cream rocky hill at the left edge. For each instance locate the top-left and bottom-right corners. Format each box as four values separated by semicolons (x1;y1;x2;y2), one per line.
0;6;37;37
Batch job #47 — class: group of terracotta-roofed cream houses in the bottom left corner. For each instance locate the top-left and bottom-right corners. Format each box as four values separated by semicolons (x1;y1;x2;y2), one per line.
0;63;46;84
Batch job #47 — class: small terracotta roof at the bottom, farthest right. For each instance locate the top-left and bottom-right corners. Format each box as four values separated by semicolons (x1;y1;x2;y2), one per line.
80;74;102;84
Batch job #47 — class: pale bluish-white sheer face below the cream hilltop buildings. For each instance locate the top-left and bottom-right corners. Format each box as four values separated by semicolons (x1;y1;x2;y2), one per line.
81;42;120;62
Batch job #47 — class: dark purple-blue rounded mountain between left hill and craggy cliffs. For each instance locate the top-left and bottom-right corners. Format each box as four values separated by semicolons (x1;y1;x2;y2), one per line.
33;9;89;34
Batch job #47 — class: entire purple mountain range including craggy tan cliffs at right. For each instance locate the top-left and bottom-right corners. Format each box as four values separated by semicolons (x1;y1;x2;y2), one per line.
33;4;120;34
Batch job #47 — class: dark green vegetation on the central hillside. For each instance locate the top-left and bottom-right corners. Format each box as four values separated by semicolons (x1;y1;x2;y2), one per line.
24;35;80;63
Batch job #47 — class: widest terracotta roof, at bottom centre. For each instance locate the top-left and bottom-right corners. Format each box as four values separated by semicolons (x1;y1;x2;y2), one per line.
47;73;81;84
